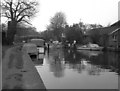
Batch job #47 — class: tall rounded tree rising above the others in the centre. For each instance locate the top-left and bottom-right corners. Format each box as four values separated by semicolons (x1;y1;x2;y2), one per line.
49;12;67;40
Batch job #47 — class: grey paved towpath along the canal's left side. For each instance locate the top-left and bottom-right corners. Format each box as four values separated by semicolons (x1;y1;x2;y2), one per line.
2;46;46;90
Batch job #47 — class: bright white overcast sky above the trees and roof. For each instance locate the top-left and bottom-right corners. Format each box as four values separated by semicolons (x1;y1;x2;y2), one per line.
32;0;120;31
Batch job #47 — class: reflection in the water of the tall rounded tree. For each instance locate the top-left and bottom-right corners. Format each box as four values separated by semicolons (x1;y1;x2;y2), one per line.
49;50;64;77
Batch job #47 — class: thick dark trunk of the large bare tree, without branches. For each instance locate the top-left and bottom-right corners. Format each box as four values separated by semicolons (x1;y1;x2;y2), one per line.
7;21;17;44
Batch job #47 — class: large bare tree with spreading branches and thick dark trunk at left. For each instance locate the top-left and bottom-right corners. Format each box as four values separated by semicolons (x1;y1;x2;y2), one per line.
2;0;38;43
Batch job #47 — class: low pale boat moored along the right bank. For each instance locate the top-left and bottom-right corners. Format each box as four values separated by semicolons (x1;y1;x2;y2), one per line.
77;44;103;51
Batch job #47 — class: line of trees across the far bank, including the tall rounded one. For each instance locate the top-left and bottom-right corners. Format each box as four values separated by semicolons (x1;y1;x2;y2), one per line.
41;12;103;44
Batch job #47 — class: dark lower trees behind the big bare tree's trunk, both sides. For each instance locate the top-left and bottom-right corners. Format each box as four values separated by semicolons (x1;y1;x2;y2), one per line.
0;23;40;45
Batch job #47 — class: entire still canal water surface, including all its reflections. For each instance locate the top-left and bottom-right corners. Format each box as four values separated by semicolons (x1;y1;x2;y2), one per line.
34;49;120;89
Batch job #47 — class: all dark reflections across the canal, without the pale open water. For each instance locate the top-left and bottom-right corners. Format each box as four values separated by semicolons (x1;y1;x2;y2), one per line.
37;49;120;77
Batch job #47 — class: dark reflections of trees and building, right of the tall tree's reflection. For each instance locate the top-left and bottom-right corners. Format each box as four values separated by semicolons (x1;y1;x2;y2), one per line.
64;50;120;75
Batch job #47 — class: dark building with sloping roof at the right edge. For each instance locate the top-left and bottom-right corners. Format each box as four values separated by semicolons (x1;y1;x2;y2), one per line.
86;21;120;51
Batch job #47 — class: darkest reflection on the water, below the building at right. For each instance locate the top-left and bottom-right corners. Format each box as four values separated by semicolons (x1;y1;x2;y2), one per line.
90;52;119;73
